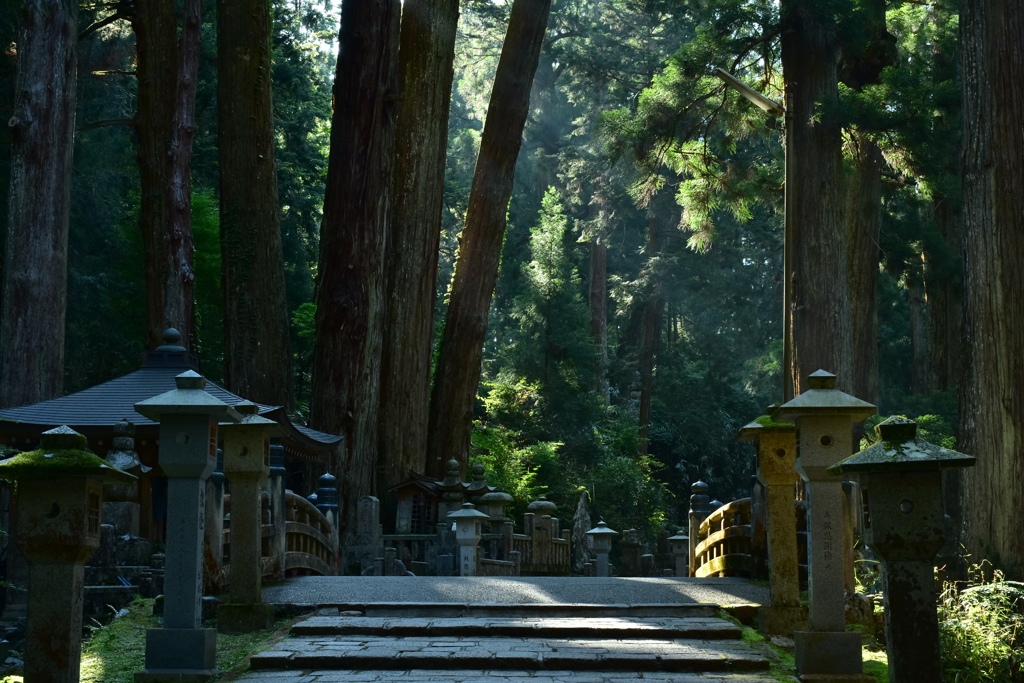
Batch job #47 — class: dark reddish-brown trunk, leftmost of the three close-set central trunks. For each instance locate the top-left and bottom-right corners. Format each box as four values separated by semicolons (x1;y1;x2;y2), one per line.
310;0;402;538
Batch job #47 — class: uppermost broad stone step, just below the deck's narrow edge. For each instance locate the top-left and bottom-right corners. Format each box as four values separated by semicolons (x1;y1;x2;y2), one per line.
291;615;741;640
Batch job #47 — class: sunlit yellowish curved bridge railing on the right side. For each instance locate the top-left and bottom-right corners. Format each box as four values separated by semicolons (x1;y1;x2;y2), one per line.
694;498;753;577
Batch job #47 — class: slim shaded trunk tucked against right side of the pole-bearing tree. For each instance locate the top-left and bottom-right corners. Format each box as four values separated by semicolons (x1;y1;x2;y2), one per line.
846;132;885;405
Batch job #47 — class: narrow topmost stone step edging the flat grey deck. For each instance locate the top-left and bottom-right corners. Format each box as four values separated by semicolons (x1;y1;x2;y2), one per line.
284;602;719;618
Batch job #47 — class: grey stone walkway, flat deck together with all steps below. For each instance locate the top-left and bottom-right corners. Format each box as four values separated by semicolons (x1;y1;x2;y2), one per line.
232;577;774;683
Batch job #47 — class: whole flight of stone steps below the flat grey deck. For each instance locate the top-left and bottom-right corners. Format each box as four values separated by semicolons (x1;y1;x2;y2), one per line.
239;603;774;683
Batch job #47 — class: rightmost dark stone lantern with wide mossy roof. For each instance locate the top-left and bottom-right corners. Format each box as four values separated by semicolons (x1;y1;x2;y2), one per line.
828;417;975;683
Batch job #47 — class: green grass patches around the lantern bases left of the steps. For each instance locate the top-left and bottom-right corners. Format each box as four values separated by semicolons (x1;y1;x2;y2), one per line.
74;598;294;683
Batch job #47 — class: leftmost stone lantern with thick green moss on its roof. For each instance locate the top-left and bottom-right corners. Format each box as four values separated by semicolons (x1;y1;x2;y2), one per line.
0;427;135;683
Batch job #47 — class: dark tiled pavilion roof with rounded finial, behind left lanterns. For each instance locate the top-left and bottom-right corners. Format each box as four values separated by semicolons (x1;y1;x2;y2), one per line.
0;329;342;461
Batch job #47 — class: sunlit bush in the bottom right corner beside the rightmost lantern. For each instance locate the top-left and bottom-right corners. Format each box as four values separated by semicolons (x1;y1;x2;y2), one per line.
939;561;1024;683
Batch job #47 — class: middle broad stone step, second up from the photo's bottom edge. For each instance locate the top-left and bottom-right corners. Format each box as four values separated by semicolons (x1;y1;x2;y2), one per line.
250;635;769;673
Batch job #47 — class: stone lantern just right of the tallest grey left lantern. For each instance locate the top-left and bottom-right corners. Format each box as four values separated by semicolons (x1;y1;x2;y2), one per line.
217;400;284;633
